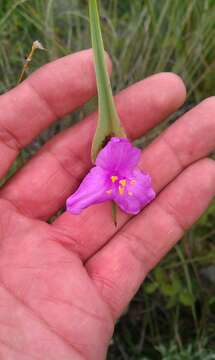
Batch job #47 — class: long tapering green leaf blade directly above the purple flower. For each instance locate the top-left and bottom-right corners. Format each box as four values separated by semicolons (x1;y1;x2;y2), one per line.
89;0;126;162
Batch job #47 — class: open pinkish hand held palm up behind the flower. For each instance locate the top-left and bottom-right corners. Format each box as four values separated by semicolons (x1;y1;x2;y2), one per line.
0;50;215;360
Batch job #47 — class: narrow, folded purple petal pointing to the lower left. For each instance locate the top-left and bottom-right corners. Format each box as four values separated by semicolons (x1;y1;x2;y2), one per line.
66;167;112;214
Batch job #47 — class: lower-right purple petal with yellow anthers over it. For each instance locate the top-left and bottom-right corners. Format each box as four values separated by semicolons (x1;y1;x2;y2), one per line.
113;169;155;215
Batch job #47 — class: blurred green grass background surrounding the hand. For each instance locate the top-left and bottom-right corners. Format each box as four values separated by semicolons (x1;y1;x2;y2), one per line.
0;0;215;360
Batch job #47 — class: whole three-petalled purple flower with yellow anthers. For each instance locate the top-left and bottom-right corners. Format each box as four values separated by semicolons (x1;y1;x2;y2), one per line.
66;137;155;214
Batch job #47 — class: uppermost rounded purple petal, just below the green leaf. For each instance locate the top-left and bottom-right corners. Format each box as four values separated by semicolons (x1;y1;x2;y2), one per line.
96;137;141;176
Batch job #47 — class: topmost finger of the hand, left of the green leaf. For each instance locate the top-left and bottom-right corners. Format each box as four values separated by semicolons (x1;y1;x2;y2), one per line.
0;50;107;177
